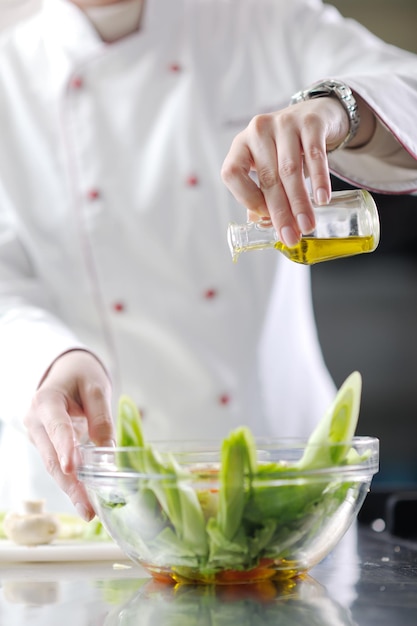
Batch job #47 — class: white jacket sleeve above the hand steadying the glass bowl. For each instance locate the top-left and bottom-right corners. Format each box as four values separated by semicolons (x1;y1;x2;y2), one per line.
0;202;83;428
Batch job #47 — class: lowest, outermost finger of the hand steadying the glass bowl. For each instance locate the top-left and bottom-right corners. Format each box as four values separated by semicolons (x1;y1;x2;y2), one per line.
32;424;95;521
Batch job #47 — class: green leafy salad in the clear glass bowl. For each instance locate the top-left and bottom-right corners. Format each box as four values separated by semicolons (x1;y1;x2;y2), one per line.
87;372;372;583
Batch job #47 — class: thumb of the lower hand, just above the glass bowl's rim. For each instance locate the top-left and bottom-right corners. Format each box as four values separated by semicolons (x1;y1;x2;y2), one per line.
80;384;115;446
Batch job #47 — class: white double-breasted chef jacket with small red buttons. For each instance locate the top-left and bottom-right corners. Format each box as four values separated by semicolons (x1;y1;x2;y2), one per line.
0;0;417;510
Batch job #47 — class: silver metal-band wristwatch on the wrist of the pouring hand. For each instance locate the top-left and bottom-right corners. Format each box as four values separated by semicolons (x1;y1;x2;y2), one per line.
290;78;360;152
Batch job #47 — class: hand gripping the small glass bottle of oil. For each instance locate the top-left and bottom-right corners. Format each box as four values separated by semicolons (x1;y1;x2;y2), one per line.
222;97;349;246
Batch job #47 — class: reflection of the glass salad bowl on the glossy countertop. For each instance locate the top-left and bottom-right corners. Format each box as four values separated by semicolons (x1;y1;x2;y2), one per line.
104;576;354;626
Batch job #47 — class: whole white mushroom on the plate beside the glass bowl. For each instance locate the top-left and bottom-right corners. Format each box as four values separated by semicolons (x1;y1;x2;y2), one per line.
3;500;59;546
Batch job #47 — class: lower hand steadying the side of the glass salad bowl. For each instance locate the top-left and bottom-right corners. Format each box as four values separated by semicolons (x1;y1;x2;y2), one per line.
25;350;114;520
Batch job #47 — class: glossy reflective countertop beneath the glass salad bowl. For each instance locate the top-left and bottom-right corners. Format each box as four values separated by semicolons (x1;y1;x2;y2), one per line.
0;524;417;626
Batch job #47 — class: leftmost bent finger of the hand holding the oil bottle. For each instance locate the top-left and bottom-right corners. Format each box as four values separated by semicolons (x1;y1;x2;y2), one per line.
221;133;268;216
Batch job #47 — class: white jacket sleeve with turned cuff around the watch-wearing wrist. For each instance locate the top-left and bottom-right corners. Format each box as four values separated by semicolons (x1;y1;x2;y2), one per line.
291;0;417;193
